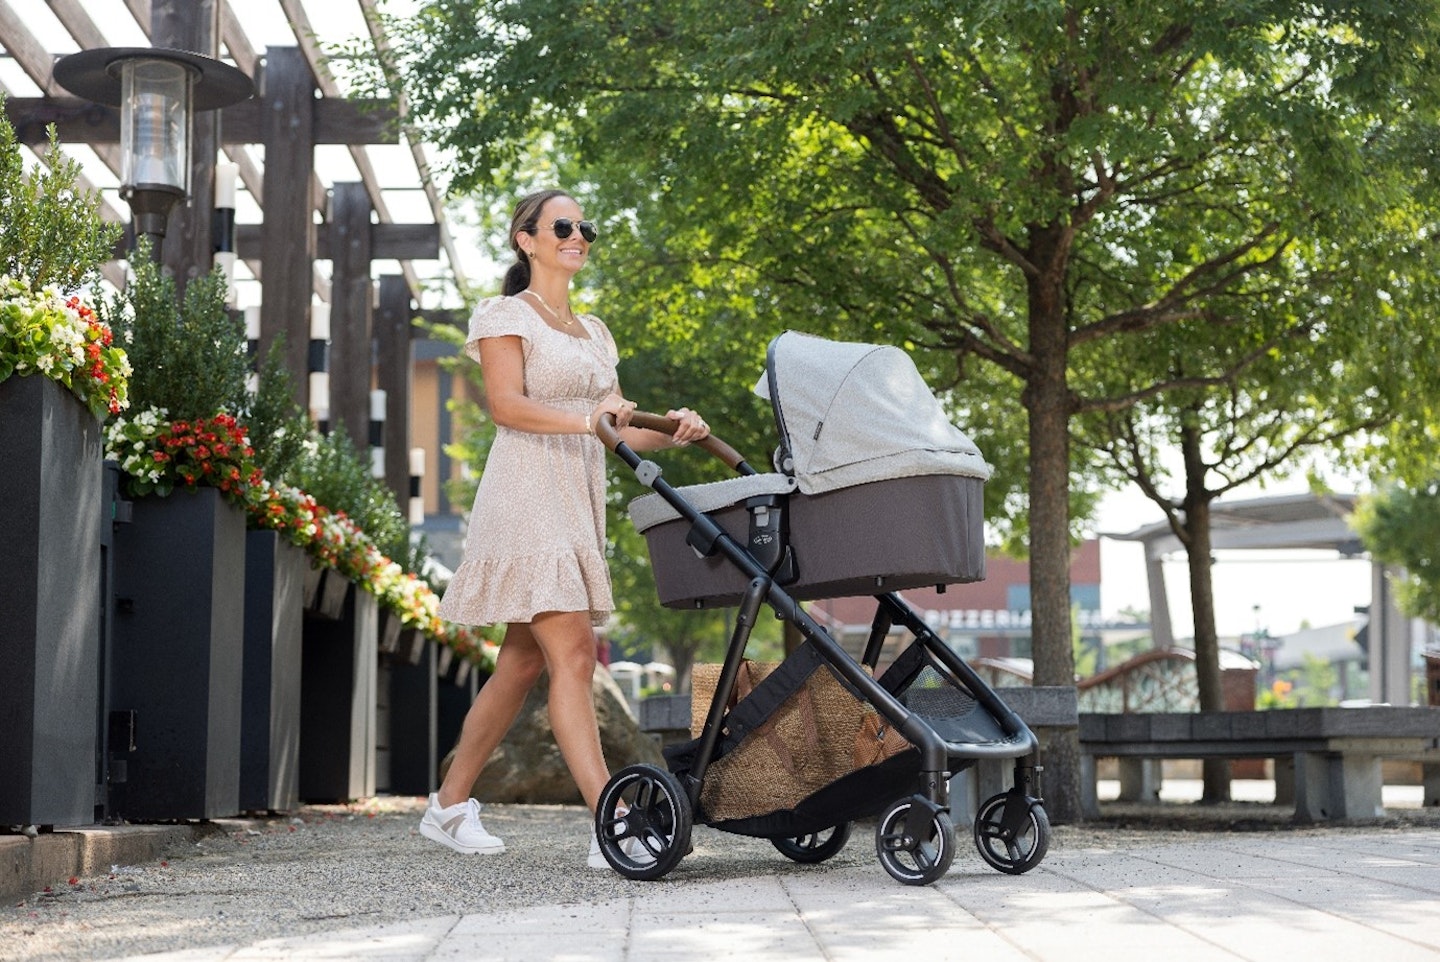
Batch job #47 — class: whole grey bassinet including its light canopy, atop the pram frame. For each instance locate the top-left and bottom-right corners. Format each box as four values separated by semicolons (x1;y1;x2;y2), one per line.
631;331;989;608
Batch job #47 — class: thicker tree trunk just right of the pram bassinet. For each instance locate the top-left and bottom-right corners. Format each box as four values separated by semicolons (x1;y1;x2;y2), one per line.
1024;260;1080;824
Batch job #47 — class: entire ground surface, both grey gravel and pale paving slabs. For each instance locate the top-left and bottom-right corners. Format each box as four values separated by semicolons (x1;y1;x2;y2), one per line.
0;805;1440;962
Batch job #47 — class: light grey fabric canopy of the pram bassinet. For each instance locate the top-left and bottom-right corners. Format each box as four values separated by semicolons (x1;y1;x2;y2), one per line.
755;331;991;494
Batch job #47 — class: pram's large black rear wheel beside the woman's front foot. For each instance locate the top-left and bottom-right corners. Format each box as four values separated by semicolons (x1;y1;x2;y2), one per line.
595;765;693;880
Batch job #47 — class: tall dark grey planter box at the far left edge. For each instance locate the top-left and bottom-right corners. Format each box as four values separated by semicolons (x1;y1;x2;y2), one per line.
0;376;104;825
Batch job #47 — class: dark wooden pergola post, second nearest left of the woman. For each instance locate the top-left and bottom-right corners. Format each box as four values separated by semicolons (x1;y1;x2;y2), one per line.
330;181;371;448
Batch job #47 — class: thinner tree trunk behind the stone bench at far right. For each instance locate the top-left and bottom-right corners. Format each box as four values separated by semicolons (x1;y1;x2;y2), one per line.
1181;428;1230;802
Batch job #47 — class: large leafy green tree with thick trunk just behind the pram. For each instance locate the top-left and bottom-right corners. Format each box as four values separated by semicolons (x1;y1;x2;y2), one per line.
368;0;1440;821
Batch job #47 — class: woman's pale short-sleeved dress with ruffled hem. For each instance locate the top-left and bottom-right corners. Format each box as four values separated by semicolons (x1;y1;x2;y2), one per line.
439;297;618;625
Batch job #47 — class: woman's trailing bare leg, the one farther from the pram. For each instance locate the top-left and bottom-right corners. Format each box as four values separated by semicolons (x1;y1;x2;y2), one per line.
436;624;544;808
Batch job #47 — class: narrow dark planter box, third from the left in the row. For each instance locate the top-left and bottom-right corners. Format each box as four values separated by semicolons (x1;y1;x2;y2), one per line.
240;531;310;812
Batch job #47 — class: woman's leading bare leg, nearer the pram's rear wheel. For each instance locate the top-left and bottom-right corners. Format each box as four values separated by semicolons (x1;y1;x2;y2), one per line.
530;612;611;812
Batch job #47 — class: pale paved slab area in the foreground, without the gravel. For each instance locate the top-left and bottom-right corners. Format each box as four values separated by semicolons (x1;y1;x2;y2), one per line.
115;831;1440;962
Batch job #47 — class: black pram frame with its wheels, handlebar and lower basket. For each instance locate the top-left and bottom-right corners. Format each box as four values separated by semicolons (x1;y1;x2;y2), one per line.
595;336;1050;884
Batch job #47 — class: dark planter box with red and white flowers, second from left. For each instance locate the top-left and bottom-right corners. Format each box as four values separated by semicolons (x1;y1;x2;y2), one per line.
109;488;245;821
